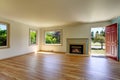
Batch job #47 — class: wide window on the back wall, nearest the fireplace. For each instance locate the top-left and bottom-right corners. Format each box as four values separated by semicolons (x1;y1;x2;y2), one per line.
45;30;62;45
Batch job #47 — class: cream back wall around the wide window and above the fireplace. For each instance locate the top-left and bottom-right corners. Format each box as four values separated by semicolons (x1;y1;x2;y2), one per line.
40;22;111;52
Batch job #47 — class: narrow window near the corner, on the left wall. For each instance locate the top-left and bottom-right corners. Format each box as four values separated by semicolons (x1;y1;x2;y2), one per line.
29;29;37;45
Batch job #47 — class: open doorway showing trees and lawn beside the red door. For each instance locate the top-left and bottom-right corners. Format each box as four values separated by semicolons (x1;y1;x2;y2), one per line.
91;27;105;56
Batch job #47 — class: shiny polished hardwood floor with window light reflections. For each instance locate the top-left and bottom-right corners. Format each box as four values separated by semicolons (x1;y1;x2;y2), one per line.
0;52;120;80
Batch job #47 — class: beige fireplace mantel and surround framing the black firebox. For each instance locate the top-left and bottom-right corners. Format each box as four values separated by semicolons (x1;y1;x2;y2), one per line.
67;38;89;55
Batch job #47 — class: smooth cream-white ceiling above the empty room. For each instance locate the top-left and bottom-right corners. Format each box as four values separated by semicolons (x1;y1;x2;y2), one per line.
0;0;120;27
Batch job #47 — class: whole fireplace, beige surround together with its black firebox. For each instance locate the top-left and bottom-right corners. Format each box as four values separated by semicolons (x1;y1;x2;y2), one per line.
67;38;89;55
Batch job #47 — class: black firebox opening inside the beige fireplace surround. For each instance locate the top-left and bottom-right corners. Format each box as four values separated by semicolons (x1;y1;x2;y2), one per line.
70;45;83;54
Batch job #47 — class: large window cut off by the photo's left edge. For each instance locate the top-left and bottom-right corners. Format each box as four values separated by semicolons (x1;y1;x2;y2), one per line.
0;22;9;48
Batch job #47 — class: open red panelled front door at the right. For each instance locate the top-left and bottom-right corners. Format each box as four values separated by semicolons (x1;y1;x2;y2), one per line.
105;23;118;60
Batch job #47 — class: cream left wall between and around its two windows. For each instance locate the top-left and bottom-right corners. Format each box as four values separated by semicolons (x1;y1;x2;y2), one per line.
0;18;39;59
